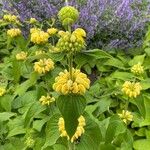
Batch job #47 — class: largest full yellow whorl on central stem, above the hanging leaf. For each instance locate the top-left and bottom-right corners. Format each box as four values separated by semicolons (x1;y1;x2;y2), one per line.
53;68;90;95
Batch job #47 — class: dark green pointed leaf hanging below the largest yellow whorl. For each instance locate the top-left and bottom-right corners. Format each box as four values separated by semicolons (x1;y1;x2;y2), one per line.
57;95;86;137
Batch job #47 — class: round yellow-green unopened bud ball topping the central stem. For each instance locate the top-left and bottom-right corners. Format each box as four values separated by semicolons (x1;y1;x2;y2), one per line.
58;6;79;26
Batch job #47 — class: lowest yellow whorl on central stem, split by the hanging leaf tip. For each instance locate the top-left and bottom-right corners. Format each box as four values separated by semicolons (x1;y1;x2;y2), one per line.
58;116;86;143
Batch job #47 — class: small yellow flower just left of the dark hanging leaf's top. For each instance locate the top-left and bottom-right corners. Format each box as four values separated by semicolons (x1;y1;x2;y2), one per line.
39;94;55;105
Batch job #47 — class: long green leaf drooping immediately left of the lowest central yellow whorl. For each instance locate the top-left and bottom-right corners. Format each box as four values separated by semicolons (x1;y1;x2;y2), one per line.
42;114;61;150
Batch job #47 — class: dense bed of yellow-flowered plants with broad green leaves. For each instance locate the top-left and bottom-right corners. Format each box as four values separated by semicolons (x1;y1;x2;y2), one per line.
0;1;150;150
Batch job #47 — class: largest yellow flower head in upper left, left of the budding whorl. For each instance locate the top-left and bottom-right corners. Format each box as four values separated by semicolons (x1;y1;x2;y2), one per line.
30;30;49;44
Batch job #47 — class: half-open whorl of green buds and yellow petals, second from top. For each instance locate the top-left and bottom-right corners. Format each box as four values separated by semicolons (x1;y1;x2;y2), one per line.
56;28;86;52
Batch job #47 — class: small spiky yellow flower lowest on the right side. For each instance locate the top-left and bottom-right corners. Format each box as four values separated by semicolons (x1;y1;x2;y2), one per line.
118;110;133;124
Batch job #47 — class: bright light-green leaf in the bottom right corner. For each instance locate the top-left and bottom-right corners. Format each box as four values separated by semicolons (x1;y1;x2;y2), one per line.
133;139;150;150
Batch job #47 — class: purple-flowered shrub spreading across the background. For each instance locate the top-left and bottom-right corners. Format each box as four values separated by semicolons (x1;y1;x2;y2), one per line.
3;0;149;50
